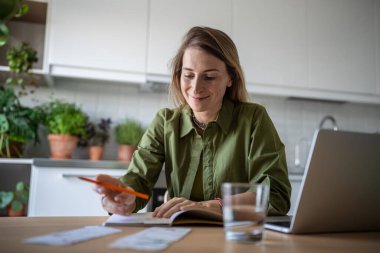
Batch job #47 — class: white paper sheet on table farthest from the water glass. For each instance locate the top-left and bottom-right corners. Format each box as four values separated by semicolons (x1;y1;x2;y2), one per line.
23;226;121;246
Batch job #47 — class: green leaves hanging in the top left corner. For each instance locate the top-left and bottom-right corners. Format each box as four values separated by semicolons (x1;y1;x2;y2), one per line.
0;0;29;46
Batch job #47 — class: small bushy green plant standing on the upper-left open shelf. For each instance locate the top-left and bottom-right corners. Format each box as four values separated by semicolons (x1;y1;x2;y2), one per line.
6;43;38;89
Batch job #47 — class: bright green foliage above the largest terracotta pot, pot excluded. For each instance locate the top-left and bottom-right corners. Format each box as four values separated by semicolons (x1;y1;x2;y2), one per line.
41;100;88;138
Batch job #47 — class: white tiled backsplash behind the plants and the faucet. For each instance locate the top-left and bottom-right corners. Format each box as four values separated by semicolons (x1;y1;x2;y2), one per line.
23;79;380;173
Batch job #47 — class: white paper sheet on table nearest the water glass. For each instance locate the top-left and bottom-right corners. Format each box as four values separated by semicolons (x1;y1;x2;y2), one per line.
110;227;191;251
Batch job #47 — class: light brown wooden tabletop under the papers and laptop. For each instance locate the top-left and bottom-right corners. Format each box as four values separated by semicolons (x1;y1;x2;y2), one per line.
0;217;380;253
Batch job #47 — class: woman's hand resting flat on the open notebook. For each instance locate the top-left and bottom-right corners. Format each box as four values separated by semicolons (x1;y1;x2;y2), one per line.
152;197;222;218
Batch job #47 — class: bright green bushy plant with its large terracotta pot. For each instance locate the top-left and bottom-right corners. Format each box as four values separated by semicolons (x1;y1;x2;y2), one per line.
42;100;88;159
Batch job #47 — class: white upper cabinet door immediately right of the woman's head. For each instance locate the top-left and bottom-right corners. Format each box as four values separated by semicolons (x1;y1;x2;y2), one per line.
233;0;307;87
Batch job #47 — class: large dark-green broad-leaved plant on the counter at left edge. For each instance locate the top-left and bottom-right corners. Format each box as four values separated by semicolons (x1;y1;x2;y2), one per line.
0;87;43;158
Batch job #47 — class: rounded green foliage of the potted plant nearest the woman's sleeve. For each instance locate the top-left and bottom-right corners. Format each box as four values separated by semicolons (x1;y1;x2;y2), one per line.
115;118;145;146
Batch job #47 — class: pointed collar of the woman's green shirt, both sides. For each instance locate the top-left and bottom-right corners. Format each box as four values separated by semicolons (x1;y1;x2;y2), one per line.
180;98;234;138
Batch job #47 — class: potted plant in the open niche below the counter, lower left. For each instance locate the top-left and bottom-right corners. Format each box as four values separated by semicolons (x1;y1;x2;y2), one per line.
0;182;29;216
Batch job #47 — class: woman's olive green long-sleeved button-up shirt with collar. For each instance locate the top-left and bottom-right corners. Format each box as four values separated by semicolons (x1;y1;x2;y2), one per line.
121;99;291;215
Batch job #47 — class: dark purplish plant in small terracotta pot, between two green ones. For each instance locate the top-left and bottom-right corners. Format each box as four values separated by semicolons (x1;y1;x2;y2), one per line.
86;118;112;160
